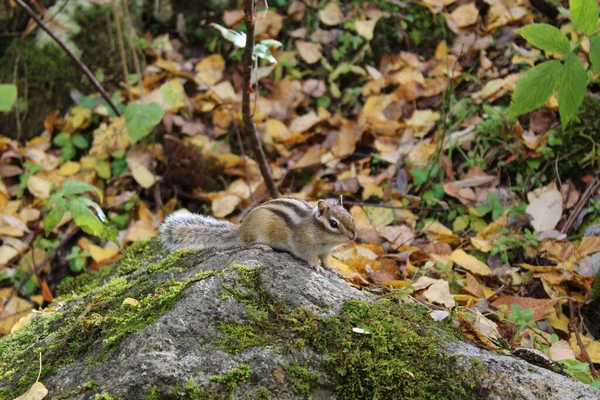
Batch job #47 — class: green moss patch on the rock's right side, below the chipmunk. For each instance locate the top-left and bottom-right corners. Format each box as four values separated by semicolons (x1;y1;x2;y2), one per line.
217;266;480;399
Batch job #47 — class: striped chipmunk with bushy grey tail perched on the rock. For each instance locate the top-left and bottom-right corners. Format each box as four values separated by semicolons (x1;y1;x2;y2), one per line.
160;197;356;271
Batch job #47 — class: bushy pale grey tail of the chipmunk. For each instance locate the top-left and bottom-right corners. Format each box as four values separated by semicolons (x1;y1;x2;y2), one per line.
160;214;242;251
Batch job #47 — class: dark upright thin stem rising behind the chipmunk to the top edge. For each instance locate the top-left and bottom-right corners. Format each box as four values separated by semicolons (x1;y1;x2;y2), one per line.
242;0;279;199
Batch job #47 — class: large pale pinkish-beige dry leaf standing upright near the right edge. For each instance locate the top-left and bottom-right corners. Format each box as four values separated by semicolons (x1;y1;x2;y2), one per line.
526;182;563;232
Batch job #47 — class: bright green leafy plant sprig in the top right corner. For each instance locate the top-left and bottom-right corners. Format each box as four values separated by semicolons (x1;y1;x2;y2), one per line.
509;0;600;126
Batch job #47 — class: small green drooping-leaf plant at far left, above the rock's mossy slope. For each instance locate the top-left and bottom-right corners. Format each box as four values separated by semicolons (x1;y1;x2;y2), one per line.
43;180;117;241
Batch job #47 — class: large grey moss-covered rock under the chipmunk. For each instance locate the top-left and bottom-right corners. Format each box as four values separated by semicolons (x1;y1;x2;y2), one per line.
0;244;600;399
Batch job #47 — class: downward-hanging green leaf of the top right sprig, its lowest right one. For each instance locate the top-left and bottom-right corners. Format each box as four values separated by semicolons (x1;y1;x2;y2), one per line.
557;54;587;125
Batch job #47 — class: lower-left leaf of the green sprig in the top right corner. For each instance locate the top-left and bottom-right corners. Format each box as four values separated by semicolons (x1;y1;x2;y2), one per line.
509;60;562;117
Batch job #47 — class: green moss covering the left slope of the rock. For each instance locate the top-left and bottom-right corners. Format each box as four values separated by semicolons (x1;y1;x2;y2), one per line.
0;242;218;399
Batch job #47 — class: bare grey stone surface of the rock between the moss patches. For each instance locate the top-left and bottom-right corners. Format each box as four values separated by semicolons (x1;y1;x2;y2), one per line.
31;249;600;400
